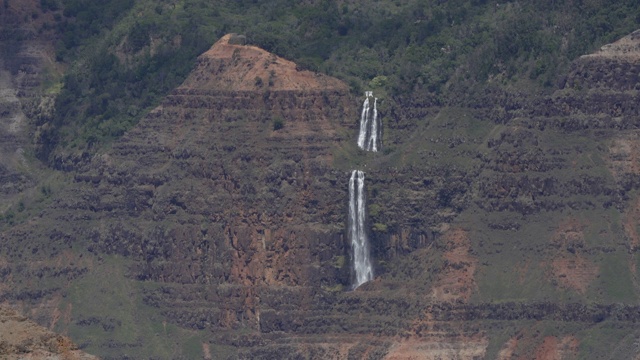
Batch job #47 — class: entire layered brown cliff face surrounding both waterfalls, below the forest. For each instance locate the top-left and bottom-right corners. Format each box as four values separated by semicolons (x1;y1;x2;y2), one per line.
0;28;640;359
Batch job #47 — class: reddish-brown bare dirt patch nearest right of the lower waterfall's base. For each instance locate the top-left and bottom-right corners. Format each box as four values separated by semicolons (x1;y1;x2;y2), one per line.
431;229;478;301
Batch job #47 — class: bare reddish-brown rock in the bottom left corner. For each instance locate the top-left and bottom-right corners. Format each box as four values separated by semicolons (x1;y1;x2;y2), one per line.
0;306;98;360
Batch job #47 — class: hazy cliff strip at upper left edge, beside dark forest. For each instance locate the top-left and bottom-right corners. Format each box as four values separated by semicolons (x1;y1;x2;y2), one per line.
0;1;55;212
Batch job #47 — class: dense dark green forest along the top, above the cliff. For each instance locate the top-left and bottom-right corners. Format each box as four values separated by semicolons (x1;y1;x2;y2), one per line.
40;0;640;162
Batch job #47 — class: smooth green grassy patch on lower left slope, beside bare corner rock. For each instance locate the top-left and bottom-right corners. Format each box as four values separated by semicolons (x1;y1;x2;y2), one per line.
56;256;202;359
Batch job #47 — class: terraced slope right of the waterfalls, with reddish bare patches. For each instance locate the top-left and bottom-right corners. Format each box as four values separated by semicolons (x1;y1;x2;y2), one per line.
236;29;640;359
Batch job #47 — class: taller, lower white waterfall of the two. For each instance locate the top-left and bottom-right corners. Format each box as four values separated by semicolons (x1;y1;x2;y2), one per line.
349;170;373;289
